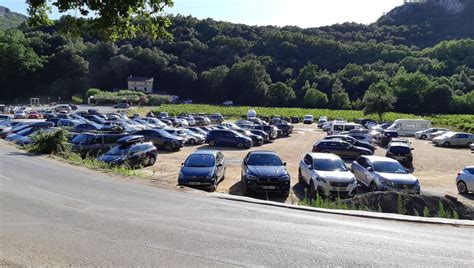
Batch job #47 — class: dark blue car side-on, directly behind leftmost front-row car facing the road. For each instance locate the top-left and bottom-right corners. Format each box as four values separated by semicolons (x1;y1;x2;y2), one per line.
206;129;252;148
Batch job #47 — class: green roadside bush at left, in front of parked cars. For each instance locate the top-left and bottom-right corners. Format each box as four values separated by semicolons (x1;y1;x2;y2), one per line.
28;130;71;154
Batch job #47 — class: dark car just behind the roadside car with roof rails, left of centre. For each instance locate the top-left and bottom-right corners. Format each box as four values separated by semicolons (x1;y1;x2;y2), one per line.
133;129;184;151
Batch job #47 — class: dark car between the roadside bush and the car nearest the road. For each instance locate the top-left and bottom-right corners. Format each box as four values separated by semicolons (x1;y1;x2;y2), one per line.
71;133;127;158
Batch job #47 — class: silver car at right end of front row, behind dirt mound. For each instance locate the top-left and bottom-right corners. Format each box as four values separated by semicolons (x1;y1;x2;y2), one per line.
352;156;420;194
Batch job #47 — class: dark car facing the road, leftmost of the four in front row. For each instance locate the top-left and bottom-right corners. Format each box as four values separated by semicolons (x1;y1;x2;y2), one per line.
178;150;226;191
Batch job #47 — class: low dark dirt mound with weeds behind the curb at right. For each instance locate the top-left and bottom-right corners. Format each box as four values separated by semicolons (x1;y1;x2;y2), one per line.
342;192;474;220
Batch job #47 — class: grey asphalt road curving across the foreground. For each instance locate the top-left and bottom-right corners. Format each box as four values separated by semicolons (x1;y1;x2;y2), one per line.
0;143;474;267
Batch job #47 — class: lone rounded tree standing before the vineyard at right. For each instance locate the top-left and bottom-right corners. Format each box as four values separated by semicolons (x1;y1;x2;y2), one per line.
362;81;397;120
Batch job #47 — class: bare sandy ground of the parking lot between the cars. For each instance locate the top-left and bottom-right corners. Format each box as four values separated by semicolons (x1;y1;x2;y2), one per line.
139;124;474;205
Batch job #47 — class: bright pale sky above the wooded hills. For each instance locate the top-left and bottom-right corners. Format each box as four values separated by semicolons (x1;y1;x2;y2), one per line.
0;0;403;28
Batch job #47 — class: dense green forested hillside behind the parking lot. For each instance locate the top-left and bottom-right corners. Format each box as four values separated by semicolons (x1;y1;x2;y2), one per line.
0;0;474;114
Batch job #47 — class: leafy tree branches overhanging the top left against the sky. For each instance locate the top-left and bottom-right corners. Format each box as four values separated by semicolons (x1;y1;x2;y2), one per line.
27;0;173;40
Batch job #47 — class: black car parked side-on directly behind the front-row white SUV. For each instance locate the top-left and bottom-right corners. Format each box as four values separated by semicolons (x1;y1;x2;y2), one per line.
313;140;373;158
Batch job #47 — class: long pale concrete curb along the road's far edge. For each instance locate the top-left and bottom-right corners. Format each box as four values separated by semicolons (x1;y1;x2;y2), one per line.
213;193;474;227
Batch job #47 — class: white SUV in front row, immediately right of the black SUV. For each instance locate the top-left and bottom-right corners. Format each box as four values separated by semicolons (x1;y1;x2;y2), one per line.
298;153;357;199
